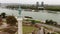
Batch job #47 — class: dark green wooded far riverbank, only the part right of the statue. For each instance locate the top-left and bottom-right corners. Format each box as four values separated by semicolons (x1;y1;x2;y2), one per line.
21;6;60;11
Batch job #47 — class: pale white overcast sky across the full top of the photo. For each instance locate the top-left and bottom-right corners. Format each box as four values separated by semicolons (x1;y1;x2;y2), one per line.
0;0;60;5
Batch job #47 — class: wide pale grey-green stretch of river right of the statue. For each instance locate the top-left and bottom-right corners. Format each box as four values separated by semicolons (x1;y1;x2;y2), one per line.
21;10;60;24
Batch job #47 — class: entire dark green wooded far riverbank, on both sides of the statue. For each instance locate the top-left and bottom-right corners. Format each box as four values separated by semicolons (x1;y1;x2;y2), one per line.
6;5;60;11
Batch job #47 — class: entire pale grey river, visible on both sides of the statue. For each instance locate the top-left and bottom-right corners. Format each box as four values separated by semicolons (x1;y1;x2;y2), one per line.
0;8;60;24
